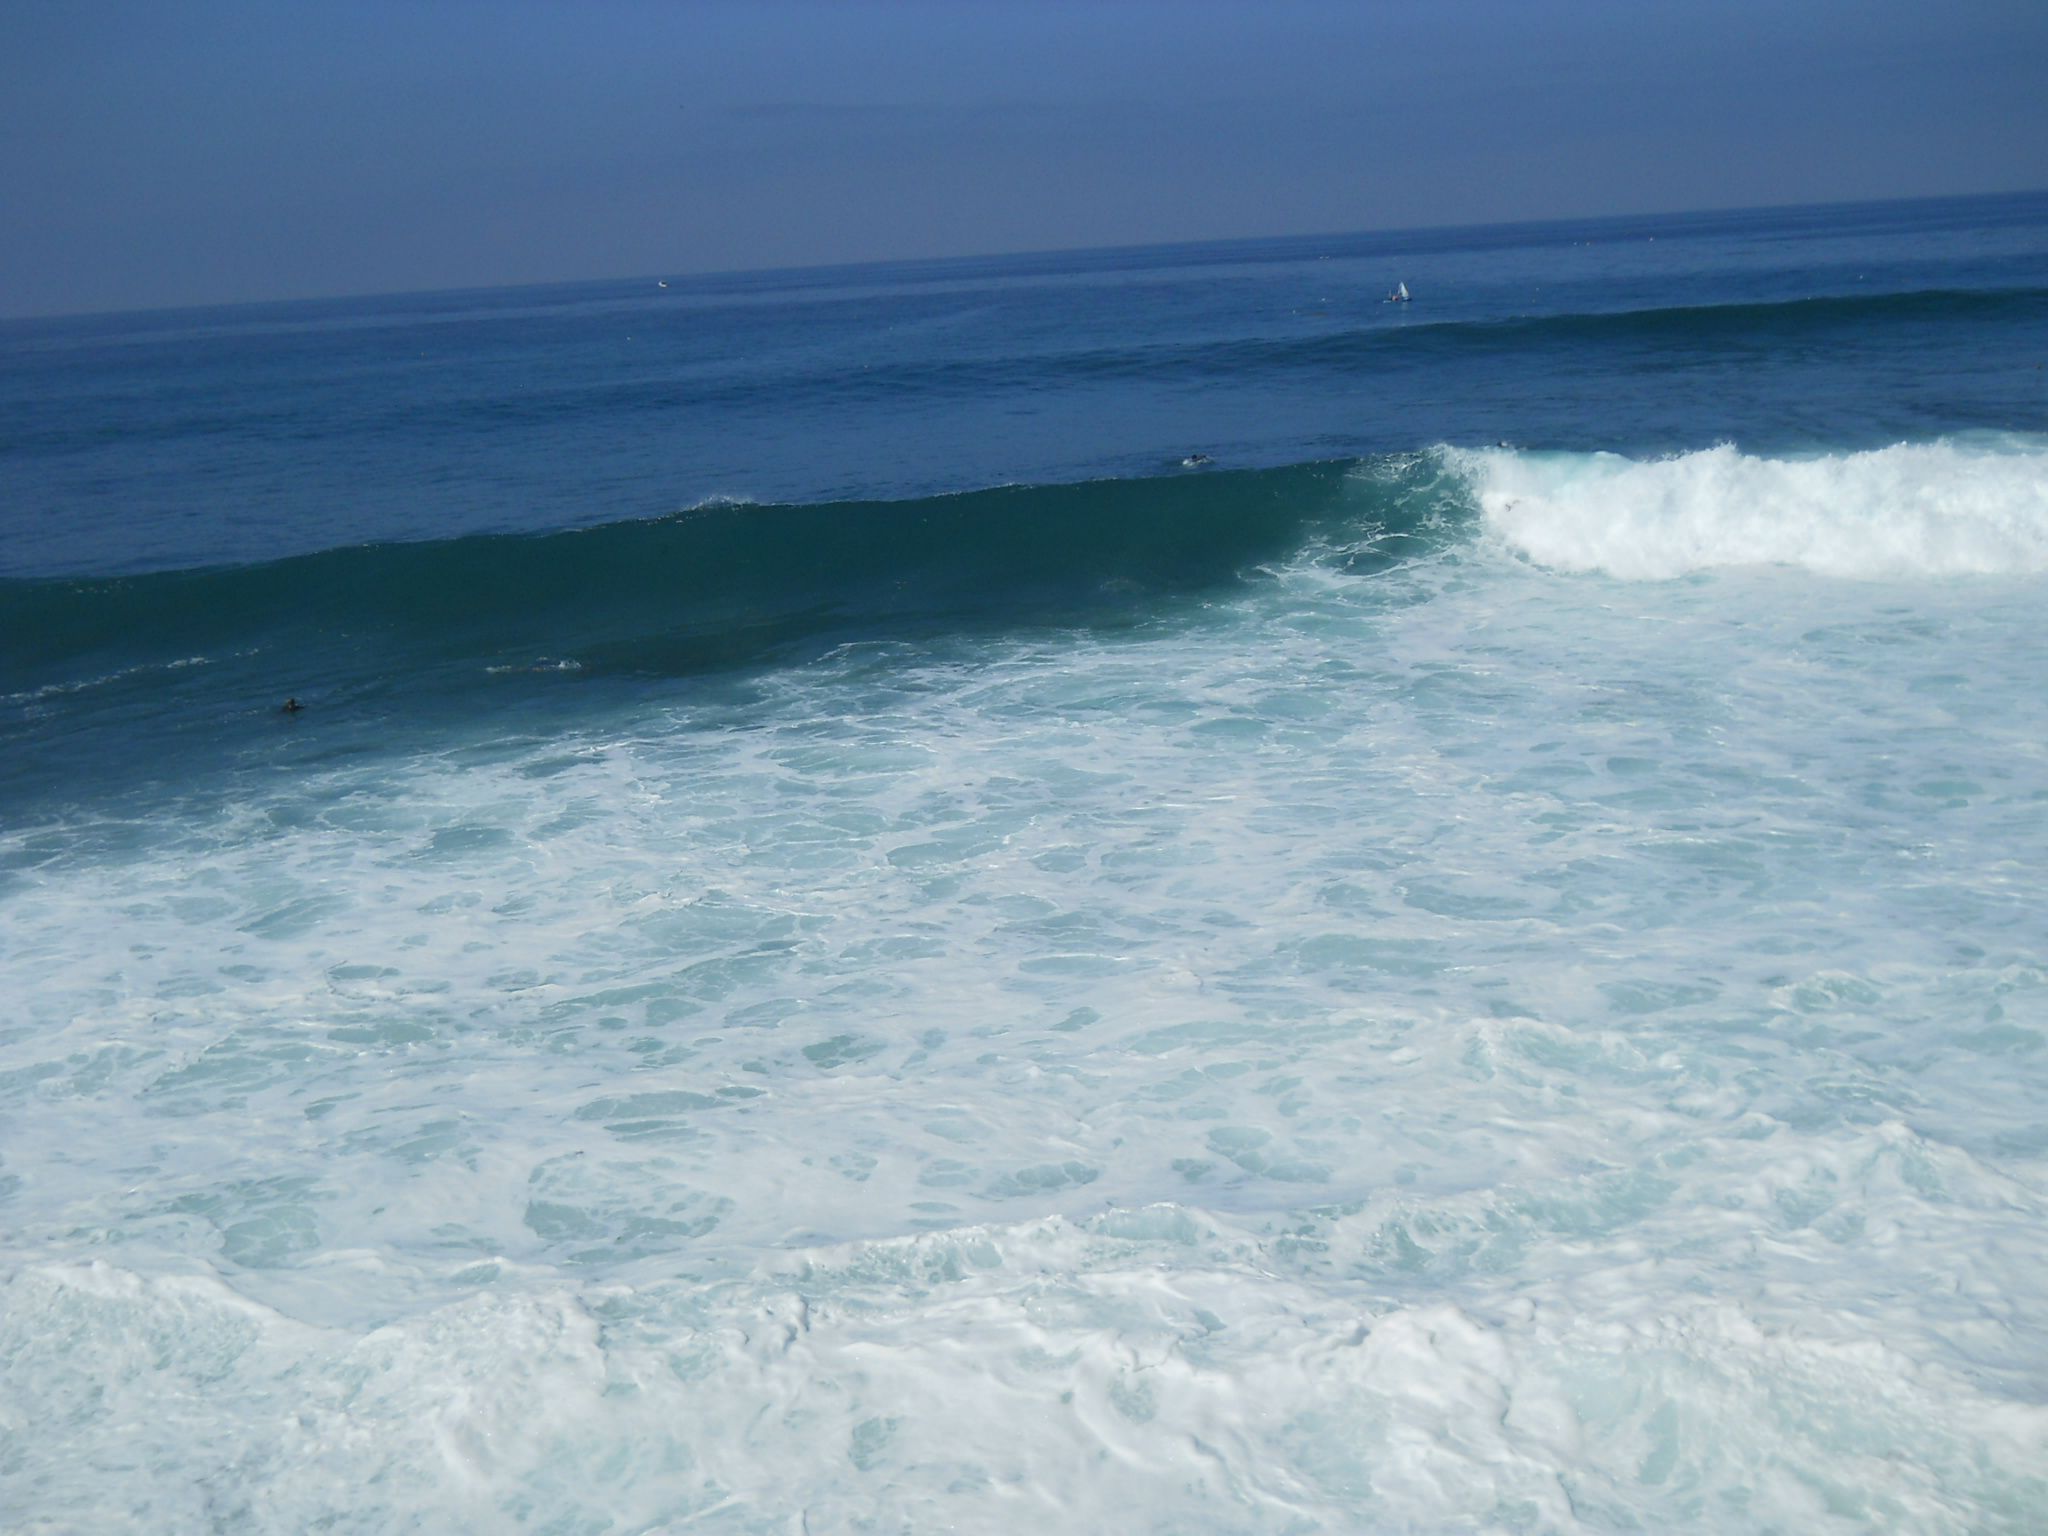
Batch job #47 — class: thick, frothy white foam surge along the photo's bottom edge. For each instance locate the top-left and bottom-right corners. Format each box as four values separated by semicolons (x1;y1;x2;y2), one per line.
16;1208;2048;1534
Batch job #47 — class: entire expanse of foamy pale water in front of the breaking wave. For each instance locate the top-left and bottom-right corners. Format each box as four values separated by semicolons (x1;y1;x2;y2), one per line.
0;514;2048;1532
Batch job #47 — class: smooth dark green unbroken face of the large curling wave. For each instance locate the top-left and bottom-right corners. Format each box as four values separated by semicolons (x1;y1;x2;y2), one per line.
0;455;1458;692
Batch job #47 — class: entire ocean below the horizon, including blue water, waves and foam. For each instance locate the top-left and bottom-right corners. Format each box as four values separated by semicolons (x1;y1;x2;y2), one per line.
12;195;2048;1536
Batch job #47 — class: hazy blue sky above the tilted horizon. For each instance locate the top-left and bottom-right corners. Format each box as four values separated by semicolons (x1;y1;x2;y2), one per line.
0;0;2048;315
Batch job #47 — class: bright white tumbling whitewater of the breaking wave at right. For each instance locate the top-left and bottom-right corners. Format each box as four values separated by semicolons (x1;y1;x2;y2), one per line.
1458;438;2048;582
